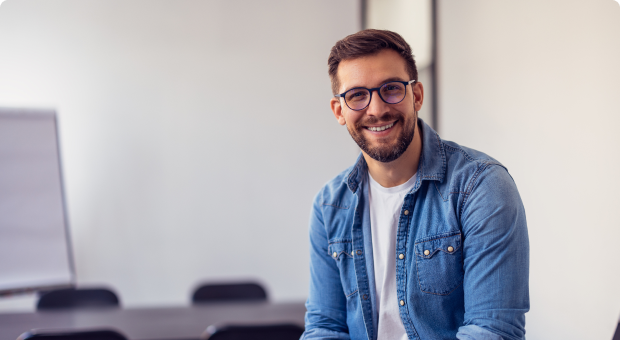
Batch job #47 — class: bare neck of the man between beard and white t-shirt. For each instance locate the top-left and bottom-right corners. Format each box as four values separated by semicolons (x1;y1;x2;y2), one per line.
362;122;422;188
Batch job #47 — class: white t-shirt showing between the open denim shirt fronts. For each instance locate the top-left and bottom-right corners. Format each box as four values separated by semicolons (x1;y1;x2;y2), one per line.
368;173;416;340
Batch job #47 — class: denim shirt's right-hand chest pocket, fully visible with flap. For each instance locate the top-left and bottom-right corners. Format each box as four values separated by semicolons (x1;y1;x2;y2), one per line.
415;232;464;295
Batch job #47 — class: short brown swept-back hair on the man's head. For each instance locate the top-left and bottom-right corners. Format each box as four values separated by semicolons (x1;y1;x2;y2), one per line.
327;29;418;95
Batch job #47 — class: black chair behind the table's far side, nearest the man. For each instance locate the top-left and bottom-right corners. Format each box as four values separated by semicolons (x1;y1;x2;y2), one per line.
192;282;267;303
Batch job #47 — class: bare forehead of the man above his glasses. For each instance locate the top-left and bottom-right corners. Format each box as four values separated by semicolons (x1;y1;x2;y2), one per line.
338;49;411;92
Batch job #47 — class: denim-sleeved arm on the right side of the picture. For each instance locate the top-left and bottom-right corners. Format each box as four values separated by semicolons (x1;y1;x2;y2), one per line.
457;165;530;340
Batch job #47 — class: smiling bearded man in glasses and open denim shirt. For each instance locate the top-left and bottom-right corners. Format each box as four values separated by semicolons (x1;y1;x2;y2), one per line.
302;30;529;340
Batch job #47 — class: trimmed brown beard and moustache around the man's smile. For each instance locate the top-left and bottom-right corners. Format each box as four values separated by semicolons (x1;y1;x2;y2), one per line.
347;112;418;163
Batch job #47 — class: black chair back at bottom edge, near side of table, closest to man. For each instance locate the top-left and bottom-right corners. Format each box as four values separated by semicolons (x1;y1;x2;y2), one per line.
202;324;304;340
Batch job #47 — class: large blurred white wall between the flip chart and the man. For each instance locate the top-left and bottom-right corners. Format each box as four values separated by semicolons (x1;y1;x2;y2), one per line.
0;0;359;308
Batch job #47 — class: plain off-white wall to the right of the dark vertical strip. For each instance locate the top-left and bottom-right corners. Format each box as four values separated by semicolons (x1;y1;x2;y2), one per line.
439;0;620;340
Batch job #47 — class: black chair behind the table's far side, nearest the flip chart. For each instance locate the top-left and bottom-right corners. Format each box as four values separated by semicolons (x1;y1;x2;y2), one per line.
37;288;120;310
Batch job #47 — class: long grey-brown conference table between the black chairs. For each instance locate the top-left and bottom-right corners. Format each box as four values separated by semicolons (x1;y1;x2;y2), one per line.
0;302;306;340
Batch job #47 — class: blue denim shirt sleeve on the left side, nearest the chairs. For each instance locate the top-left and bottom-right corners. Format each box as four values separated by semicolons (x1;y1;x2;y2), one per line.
301;195;350;340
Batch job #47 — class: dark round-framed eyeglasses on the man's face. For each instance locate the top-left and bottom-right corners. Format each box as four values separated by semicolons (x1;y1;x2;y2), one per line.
335;79;415;111
